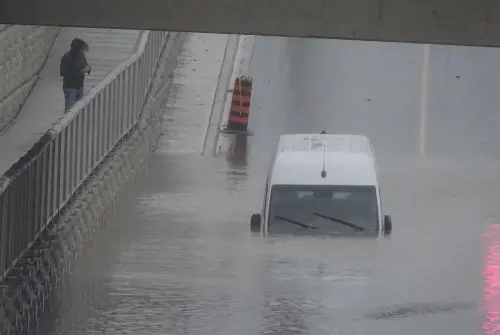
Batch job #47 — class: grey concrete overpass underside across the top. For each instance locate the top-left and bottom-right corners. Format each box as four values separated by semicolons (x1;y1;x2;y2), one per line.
0;0;500;46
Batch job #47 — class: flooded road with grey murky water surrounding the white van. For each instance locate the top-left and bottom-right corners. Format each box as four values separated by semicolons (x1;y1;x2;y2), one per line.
36;37;500;335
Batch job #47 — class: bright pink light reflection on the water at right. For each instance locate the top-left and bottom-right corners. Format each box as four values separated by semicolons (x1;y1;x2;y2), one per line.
483;224;500;335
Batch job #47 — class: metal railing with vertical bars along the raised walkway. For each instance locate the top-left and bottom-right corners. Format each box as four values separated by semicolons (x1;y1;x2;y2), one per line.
0;31;168;280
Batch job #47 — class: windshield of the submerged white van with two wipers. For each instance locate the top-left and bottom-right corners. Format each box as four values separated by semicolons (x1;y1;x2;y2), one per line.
268;185;378;233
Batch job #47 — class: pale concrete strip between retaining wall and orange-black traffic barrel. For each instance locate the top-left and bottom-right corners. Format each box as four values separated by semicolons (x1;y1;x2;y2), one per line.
157;33;228;153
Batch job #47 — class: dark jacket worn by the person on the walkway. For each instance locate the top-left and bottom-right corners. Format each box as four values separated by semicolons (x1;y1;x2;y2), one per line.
59;39;90;89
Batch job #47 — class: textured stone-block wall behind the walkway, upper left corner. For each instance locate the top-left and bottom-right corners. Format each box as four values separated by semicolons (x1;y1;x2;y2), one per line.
0;25;60;131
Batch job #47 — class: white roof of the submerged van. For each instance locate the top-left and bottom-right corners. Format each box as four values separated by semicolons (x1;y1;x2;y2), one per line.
270;134;378;186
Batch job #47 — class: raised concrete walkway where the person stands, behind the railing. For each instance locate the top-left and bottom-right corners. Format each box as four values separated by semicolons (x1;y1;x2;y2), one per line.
0;28;140;176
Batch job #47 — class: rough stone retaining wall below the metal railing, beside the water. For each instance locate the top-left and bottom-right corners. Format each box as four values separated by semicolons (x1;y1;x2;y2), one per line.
0;33;185;335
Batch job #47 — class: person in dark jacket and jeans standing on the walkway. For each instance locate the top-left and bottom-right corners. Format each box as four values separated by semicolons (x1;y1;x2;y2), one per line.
59;38;91;112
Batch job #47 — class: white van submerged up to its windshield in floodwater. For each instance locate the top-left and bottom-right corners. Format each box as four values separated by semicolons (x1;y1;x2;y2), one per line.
251;132;392;236
